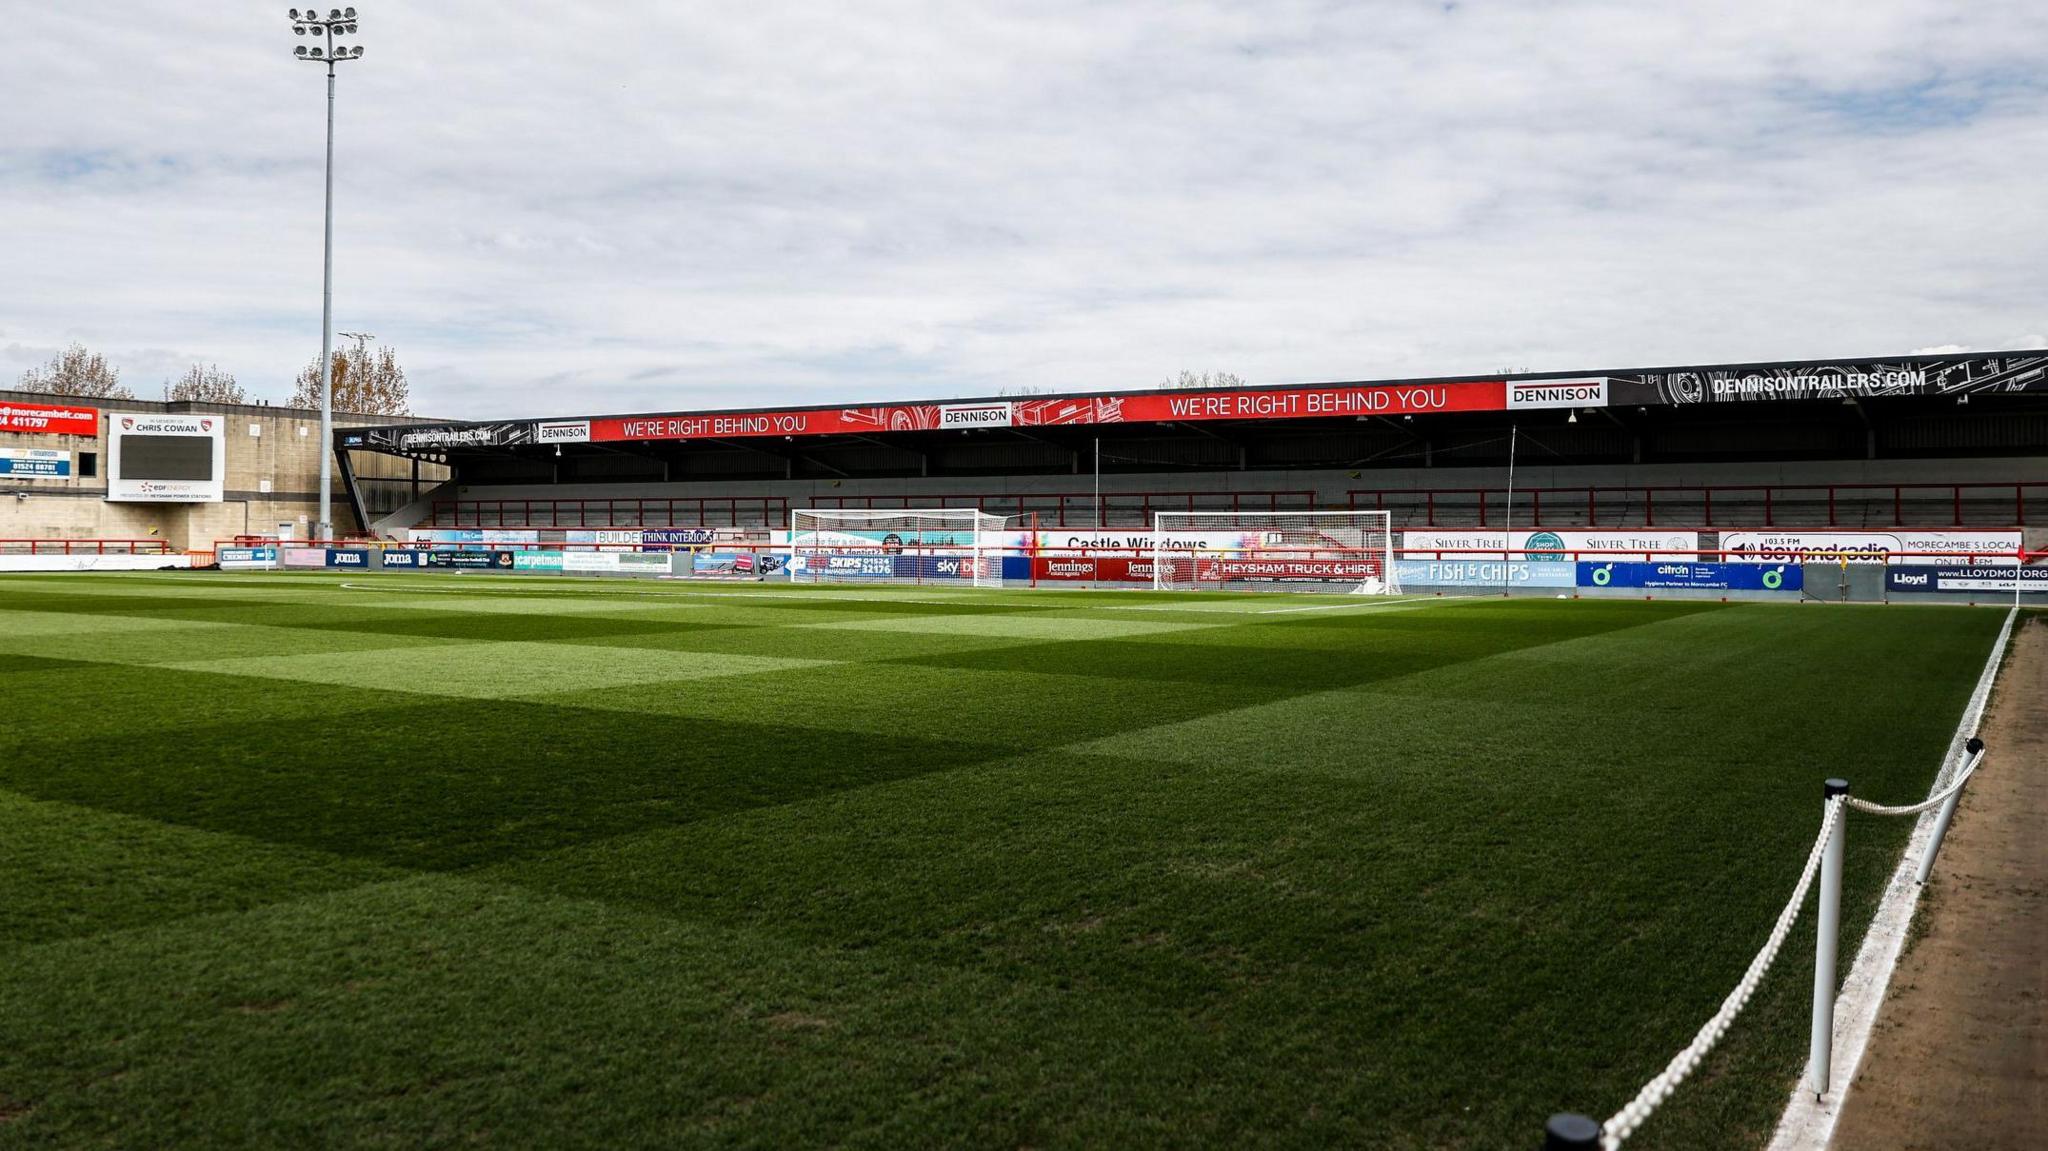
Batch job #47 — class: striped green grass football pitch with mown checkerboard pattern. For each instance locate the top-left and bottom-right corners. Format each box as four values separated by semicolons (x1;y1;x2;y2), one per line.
0;573;2001;1149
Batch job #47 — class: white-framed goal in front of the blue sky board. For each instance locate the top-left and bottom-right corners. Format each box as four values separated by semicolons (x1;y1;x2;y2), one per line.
786;508;1004;588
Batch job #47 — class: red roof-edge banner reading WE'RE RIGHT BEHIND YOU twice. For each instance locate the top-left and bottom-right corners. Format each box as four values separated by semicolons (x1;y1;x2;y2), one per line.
590;379;1507;442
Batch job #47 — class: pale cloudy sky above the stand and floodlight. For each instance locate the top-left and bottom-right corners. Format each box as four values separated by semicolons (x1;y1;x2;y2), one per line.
0;0;2048;418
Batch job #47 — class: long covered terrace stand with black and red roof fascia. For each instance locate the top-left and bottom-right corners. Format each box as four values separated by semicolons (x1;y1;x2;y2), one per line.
338;352;2048;535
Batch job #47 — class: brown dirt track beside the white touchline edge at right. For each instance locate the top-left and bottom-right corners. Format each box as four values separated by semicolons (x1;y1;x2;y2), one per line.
1833;614;2048;1151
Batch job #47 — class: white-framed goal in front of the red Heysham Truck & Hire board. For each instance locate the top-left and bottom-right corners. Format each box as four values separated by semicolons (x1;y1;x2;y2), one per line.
1153;512;1401;594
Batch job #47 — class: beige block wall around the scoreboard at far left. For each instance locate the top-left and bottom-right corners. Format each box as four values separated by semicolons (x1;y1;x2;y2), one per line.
0;391;446;549
